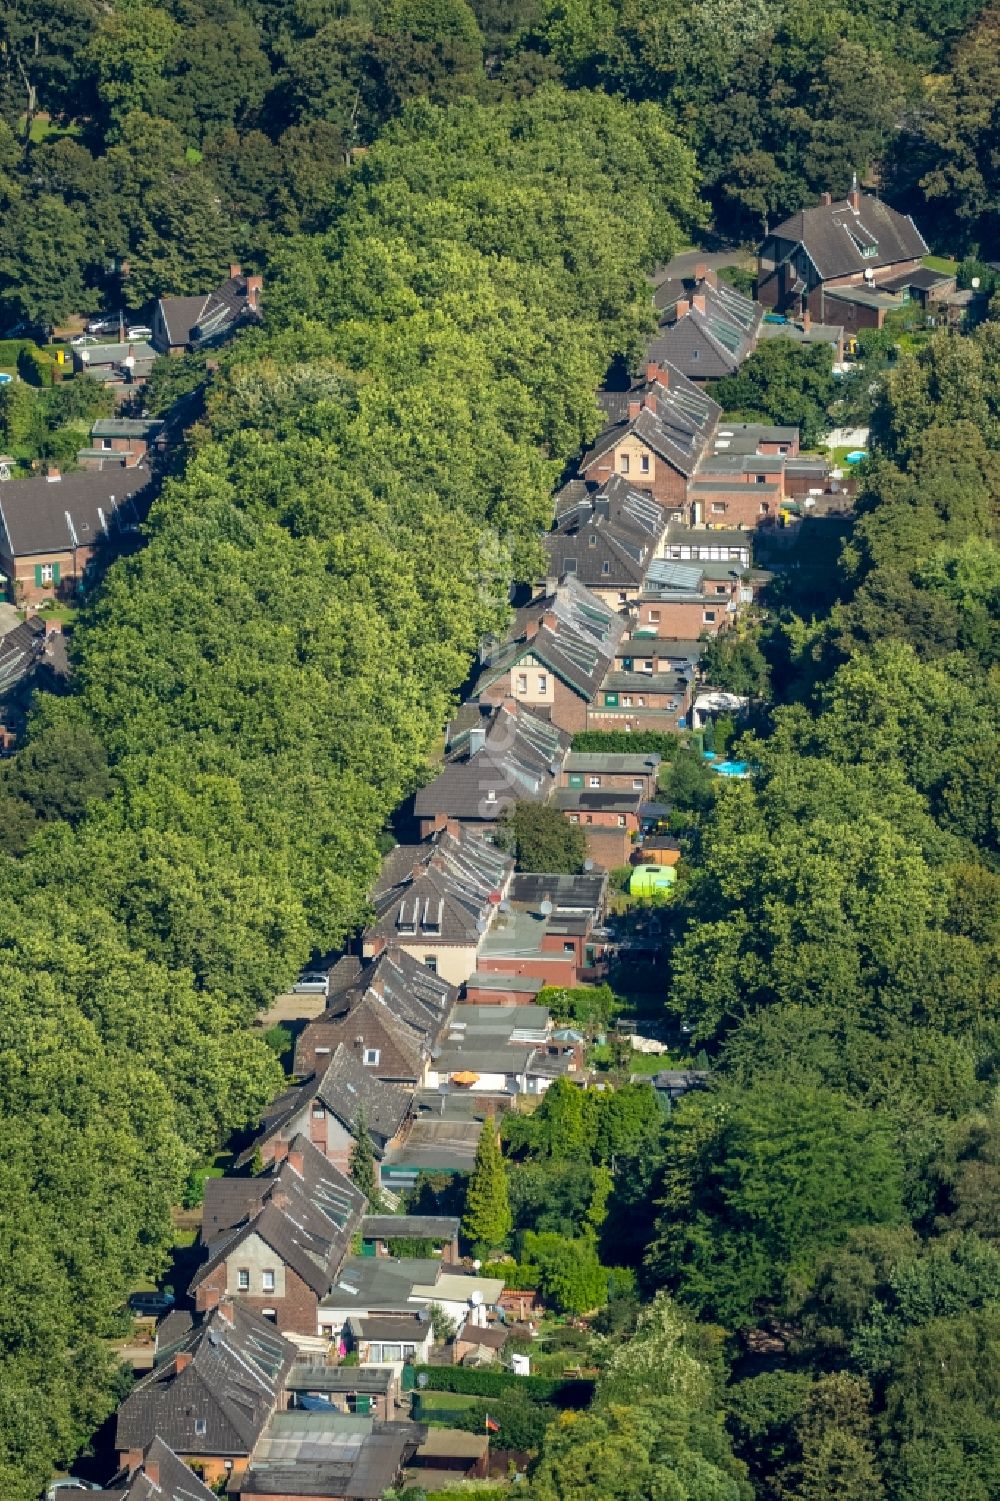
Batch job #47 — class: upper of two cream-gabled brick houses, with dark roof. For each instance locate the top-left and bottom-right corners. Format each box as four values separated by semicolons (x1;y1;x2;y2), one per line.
580;363;721;510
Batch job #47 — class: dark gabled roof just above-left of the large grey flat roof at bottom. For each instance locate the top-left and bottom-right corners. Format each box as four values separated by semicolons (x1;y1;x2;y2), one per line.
114;1303;296;1457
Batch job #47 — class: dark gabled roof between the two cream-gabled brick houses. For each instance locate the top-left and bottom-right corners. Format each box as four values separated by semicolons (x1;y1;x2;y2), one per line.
542;474;667;588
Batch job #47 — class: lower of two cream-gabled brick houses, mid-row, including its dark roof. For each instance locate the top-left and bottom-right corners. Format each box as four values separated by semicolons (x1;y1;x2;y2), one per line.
471;573;625;734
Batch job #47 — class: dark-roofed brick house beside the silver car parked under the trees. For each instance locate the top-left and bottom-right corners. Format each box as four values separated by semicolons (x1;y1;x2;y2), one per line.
294;949;459;1088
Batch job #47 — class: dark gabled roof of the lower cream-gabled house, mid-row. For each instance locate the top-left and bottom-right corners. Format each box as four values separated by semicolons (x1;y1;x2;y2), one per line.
473;575;625;701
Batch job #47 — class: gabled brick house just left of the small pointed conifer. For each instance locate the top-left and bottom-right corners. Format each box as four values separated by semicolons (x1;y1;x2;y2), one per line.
236;1043;413;1172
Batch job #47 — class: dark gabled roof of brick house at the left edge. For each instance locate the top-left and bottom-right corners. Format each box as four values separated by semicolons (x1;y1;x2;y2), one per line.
0;464;150;558
